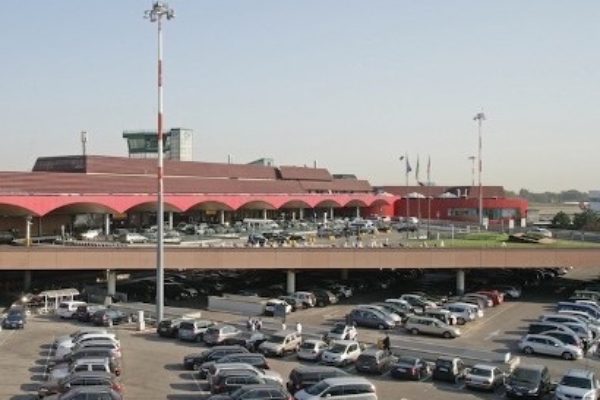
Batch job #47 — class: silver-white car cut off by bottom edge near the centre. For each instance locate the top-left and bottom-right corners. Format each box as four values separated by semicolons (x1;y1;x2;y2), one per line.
294;376;377;400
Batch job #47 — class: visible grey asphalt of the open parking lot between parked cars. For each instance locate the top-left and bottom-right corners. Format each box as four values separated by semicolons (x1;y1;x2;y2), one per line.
0;270;600;400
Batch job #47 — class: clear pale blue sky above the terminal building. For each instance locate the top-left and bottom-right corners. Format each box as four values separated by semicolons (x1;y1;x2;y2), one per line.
0;0;600;191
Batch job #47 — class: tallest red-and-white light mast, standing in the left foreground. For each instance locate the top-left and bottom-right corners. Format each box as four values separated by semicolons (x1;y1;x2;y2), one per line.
145;1;175;323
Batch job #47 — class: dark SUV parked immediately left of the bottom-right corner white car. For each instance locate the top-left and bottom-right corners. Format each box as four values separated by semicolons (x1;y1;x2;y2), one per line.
504;365;552;398
